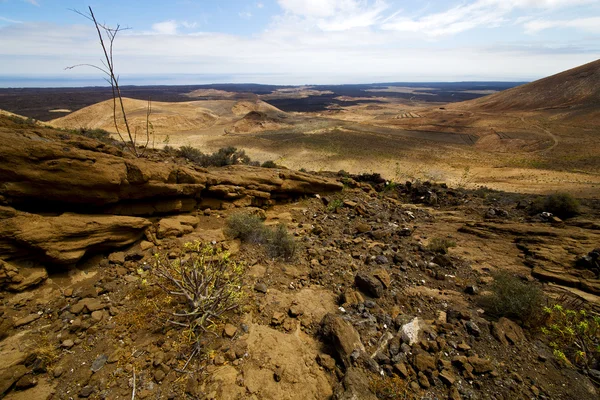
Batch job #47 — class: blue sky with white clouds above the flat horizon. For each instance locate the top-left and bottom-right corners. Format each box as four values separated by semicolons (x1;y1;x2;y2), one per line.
0;0;600;87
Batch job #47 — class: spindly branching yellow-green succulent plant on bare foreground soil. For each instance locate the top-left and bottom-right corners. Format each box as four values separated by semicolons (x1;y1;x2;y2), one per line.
152;241;244;331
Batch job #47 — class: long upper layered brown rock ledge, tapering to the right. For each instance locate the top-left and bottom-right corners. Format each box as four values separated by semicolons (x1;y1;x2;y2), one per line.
0;129;342;215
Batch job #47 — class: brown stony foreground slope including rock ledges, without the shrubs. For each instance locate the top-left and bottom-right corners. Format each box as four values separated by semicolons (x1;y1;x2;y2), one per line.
0;115;600;399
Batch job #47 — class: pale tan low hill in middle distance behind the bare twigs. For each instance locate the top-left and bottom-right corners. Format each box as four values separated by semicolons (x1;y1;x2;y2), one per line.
49;98;285;133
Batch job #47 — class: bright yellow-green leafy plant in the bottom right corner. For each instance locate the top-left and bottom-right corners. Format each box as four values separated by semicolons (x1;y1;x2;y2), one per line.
541;304;600;368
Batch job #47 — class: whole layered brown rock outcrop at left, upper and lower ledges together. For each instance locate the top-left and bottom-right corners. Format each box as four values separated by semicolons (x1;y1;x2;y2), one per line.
0;127;342;272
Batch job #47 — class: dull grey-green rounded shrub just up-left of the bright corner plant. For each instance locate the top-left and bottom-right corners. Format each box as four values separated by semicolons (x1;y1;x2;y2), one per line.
479;272;544;325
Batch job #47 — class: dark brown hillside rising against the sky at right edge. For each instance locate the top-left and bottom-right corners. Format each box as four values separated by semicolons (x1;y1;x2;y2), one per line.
461;60;600;115
